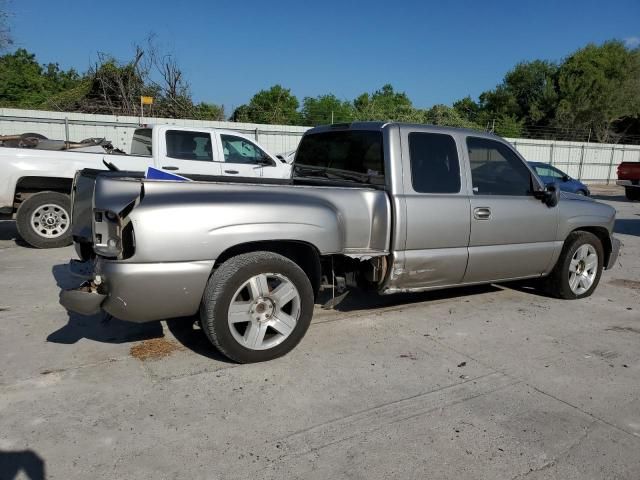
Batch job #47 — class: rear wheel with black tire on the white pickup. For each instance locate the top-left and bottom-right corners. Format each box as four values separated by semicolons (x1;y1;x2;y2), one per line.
16;192;72;248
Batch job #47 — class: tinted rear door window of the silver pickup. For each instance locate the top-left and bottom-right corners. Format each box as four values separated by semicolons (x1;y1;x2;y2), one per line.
409;132;460;193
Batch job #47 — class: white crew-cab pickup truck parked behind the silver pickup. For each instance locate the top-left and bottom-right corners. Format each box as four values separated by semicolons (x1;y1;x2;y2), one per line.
0;125;291;248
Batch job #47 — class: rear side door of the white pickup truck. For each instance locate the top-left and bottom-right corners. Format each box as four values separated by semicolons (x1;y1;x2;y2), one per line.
156;129;220;175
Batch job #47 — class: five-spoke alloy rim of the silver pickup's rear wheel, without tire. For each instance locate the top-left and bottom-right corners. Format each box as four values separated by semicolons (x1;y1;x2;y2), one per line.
227;273;300;350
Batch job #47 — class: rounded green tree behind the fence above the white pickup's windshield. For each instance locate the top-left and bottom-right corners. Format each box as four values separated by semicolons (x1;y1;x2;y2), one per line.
233;85;301;125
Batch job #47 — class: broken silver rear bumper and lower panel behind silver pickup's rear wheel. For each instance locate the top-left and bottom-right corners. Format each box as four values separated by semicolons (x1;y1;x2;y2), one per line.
60;259;214;323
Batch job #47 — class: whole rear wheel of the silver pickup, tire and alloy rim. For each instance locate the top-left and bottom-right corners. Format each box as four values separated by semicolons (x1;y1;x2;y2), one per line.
200;252;314;363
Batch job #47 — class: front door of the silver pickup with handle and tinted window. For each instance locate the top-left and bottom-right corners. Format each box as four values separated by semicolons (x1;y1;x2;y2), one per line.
464;136;558;282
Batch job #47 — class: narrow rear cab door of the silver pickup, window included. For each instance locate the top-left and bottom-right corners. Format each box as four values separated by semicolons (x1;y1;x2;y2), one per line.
394;128;470;289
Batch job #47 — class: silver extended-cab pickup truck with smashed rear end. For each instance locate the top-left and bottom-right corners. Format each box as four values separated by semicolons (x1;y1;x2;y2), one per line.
61;123;620;362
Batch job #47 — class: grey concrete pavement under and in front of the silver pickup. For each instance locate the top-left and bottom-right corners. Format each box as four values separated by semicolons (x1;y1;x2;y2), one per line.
0;188;640;479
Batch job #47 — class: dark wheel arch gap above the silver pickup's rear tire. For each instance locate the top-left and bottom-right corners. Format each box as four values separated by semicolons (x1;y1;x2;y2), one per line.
214;240;321;297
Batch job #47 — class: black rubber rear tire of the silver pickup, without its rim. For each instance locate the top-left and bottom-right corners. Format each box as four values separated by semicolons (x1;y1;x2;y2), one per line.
200;251;314;363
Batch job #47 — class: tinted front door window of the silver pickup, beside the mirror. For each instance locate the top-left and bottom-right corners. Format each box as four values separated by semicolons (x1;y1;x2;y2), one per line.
467;137;532;196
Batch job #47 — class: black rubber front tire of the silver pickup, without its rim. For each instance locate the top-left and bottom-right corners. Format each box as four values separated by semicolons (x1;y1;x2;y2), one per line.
545;231;604;300
